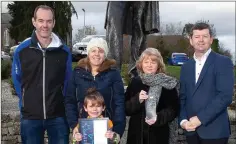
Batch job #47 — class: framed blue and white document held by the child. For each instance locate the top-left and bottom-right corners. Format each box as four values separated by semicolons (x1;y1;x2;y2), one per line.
79;118;109;144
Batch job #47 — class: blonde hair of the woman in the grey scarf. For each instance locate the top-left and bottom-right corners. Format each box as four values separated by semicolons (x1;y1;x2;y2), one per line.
136;48;166;73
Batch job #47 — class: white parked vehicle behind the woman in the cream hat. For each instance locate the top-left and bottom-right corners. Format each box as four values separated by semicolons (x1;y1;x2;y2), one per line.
72;35;106;61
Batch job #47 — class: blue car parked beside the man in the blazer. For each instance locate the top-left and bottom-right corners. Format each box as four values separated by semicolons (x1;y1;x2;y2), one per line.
168;53;189;65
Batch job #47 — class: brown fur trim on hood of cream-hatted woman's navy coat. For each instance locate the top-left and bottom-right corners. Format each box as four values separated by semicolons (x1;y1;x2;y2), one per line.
77;57;116;72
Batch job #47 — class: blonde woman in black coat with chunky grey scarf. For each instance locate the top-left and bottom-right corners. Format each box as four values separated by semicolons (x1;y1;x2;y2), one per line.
125;48;179;144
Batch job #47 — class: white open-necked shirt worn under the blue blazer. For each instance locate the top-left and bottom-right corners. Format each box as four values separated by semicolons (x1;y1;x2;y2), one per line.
180;48;211;125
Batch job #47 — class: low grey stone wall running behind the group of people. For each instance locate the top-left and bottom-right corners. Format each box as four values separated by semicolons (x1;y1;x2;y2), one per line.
1;82;236;144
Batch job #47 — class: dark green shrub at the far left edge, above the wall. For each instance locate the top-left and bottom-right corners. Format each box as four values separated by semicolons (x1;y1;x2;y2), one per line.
1;60;12;79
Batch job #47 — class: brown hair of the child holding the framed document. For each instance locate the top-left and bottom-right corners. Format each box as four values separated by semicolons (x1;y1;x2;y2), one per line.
84;88;105;107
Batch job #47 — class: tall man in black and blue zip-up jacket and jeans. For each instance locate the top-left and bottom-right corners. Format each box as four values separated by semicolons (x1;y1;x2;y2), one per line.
12;5;72;144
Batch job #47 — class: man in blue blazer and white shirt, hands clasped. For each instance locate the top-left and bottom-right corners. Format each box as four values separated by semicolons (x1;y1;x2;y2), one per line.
179;23;234;144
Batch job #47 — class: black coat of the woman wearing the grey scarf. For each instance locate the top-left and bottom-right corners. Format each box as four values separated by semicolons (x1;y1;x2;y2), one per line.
125;77;180;144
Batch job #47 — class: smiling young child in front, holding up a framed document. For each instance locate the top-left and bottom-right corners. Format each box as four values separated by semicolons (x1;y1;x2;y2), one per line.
73;88;120;144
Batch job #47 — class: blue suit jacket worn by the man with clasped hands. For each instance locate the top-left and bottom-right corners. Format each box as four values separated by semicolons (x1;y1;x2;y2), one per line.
179;51;234;139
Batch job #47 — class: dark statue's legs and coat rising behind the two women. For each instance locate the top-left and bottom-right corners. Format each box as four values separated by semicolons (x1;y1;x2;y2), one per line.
105;1;160;75
